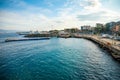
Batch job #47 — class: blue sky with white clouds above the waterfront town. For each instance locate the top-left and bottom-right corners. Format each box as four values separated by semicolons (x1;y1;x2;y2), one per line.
0;0;120;30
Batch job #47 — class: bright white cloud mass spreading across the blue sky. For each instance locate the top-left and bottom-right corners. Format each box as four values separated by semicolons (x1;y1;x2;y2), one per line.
0;0;120;30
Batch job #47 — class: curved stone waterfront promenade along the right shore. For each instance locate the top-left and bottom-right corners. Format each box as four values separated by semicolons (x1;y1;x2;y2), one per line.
81;35;120;61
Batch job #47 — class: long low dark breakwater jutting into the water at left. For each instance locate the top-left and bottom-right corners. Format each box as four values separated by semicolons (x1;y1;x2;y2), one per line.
5;37;50;42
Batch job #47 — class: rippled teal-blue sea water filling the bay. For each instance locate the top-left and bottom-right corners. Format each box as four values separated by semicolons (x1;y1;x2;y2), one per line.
0;33;120;80
